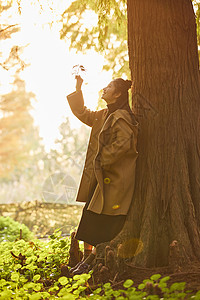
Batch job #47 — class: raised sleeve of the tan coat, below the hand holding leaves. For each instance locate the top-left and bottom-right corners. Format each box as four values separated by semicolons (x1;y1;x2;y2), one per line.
67;91;98;127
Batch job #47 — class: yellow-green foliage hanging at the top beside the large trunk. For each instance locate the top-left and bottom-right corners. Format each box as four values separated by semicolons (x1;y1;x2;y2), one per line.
60;0;200;77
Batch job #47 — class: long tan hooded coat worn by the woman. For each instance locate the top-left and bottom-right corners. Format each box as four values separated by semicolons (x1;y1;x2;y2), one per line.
67;91;138;215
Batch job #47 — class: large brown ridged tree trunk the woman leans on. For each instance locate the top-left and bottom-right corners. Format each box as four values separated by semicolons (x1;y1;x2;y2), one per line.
115;0;200;267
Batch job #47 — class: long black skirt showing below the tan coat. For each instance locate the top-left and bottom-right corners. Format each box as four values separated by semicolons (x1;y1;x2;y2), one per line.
75;198;126;246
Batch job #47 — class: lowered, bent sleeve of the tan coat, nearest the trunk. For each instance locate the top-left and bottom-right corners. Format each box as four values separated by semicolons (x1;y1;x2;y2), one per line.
100;119;137;167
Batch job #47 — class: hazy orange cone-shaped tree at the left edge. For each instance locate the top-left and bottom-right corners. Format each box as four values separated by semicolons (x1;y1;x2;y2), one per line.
0;76;34;177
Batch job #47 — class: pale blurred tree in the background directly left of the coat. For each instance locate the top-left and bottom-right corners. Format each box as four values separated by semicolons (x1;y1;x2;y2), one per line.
42;118;89;205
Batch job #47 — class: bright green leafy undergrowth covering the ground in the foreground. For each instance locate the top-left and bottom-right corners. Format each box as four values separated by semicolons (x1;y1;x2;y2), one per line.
0;231;200;300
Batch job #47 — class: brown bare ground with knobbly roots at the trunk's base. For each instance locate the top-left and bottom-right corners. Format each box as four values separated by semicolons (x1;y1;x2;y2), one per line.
70;232;200;293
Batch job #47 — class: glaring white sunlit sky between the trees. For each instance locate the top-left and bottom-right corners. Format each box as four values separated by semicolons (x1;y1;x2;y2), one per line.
1;0;112;150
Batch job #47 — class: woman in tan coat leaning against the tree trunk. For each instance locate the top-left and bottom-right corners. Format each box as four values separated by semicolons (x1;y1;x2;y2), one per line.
67;76;138;275
